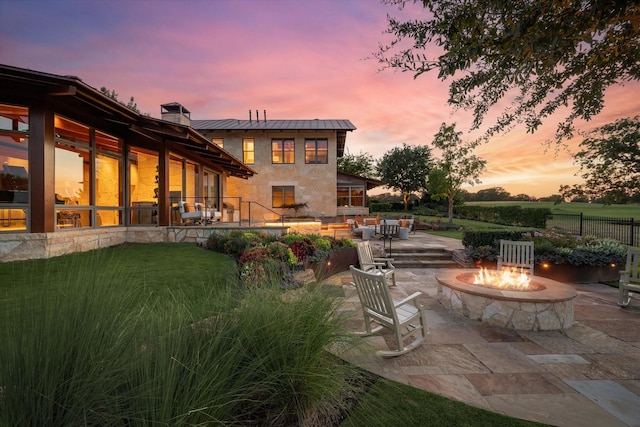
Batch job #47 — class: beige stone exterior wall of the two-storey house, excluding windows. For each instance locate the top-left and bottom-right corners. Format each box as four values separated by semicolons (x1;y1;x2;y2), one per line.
200;130;337;222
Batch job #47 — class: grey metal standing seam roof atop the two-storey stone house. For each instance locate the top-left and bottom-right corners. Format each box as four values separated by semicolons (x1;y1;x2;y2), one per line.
191;119;356;131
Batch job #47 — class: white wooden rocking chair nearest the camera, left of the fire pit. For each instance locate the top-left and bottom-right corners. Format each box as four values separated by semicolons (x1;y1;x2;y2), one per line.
350;266;427;357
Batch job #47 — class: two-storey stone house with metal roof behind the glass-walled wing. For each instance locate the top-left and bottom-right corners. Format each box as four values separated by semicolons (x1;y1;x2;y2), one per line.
191;110;356;222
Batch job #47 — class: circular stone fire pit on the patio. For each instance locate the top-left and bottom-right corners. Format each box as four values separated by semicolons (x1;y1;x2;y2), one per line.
436;270;577;331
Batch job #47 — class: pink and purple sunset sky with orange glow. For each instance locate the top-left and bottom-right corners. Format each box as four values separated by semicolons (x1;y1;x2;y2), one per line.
0;0;640;197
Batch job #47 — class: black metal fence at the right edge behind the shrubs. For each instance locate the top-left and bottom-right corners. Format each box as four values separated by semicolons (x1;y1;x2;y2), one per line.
547;213;640;246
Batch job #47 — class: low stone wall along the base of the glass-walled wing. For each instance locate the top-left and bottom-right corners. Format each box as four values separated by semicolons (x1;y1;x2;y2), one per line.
0;222;320;262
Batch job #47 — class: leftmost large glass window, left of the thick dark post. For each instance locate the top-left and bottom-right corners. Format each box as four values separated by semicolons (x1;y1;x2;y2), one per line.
0;104;29;231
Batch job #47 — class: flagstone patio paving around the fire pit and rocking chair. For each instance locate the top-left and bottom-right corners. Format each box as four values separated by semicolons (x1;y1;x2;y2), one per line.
327;233;640;427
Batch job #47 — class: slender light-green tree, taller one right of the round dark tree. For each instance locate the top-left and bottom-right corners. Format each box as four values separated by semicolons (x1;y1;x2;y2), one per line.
427;123;487;224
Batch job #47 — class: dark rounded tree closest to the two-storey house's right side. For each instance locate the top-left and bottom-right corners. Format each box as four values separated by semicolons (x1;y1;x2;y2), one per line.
377;144;431;210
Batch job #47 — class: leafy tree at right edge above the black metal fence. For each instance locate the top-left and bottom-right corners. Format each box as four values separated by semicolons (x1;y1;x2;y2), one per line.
561;116;640;203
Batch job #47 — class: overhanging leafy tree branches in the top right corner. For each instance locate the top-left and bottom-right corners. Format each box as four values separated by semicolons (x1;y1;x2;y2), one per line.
374;0;640;140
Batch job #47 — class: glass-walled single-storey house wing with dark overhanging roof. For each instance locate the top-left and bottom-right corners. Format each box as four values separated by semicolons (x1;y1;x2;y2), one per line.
0;65;256;262
